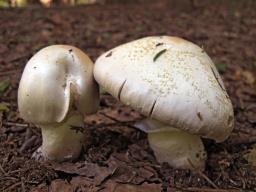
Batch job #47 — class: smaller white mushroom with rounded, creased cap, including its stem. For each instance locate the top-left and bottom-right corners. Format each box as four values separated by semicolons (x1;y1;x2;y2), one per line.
18;45;99;161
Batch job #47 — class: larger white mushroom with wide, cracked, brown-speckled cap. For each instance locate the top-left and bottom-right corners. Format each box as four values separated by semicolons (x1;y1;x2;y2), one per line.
94;36;234;169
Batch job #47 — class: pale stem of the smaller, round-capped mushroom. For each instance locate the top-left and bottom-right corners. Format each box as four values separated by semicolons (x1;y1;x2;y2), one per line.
40;113;84;162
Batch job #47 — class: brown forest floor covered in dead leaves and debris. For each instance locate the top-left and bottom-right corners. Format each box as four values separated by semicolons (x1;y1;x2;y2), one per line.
0;0;256;192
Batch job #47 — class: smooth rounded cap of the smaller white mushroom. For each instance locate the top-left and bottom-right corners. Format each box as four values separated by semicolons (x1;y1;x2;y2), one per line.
18;45;99;124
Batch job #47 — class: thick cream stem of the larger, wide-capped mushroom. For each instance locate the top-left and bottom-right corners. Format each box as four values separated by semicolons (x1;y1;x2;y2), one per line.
148;127;207;170
